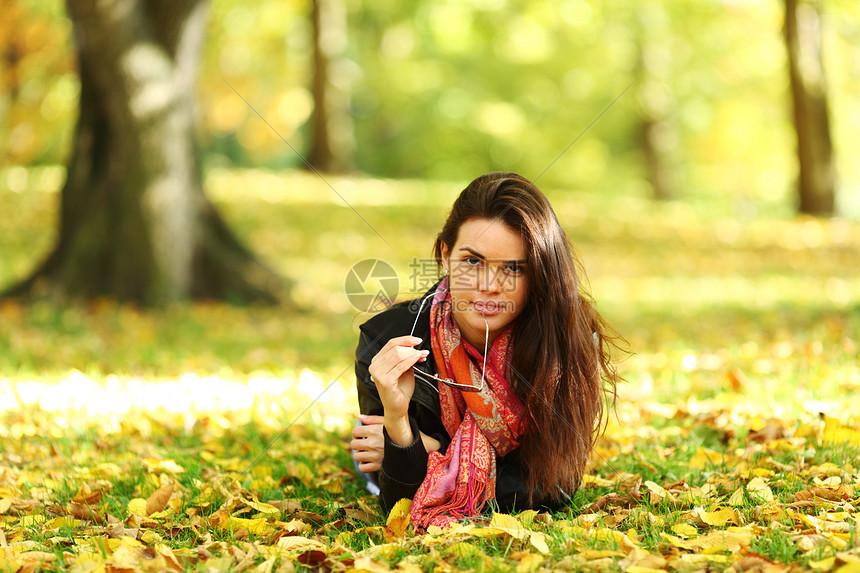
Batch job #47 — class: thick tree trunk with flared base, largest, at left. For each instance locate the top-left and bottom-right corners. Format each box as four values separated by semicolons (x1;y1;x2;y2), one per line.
6;0;280;305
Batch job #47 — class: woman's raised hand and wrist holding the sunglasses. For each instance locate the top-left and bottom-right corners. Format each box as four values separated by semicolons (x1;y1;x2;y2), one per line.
368;336;430;447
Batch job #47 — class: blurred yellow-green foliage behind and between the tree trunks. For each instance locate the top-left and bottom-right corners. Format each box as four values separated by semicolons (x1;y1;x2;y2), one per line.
0;0;860;216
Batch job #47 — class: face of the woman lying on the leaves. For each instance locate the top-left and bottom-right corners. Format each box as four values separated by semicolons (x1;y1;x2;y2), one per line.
442;219;528;346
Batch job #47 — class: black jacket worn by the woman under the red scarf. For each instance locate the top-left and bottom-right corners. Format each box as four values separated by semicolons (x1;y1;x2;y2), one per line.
355;286;566;512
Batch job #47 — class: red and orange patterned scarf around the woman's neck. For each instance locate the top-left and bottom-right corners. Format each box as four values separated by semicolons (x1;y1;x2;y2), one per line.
410;277;524;528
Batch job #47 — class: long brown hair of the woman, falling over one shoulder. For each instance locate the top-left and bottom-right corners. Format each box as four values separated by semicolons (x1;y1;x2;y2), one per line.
433;173;620;502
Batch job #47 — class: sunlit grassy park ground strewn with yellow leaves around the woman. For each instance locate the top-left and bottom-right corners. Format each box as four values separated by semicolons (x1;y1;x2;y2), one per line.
0;170;860;571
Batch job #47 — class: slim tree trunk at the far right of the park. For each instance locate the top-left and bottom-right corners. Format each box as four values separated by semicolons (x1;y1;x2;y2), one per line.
783;0;836;216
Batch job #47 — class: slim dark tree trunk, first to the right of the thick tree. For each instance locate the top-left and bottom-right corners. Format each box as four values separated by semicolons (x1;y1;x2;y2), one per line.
308;0;354;172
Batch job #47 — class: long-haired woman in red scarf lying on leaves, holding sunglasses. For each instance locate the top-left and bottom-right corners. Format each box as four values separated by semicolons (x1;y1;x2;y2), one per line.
351;173;618;527
